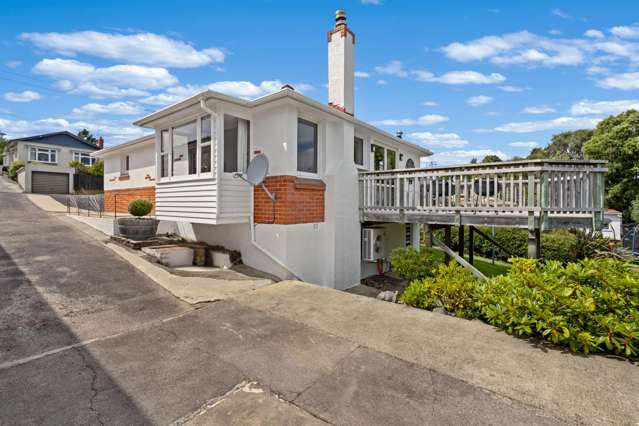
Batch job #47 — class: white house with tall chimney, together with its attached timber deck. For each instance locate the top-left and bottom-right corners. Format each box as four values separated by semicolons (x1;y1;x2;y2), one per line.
95;11;606;289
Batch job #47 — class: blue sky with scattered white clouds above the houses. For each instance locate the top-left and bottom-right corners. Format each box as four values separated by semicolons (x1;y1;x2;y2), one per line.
0;0;639;164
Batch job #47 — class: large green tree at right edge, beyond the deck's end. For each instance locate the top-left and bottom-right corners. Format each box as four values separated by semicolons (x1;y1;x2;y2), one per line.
583;110;639;220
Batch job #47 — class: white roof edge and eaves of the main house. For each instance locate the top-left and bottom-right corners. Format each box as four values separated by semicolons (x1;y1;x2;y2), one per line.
133;86;433;156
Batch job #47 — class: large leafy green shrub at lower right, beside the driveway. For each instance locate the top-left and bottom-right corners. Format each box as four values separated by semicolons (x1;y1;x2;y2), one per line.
475;259;639;358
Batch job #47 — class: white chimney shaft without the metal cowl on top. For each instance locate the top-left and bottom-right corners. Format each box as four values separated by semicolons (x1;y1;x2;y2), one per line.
328;32;355;113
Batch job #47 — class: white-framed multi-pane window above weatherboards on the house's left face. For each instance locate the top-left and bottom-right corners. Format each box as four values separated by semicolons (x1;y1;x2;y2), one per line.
157;112;219;182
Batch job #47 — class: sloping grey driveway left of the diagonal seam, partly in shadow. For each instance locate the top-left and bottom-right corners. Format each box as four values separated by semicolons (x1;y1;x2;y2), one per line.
0;177;561;425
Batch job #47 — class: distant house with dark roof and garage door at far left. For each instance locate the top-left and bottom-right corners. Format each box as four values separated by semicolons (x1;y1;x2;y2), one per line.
3;131;102;194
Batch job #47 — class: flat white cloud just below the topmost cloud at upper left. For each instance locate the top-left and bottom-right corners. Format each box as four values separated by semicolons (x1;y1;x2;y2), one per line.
33;58;178;98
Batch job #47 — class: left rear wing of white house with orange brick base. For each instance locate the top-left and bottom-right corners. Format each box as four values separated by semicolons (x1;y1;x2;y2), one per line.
93;135;157;213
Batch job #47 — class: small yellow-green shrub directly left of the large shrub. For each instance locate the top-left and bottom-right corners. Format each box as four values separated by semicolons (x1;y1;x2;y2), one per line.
400;262;478;318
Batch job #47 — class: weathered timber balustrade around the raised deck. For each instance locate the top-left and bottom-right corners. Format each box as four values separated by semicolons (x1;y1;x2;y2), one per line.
359;160;607;230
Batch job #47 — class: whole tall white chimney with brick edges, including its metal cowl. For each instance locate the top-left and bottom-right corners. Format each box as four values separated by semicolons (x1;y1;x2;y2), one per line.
328;10;355;115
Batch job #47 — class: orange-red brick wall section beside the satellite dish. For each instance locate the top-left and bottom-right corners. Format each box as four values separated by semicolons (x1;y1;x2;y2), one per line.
253;176;326;225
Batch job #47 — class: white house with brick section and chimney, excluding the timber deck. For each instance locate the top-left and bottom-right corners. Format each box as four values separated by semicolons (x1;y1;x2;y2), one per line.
96;11;431;289
